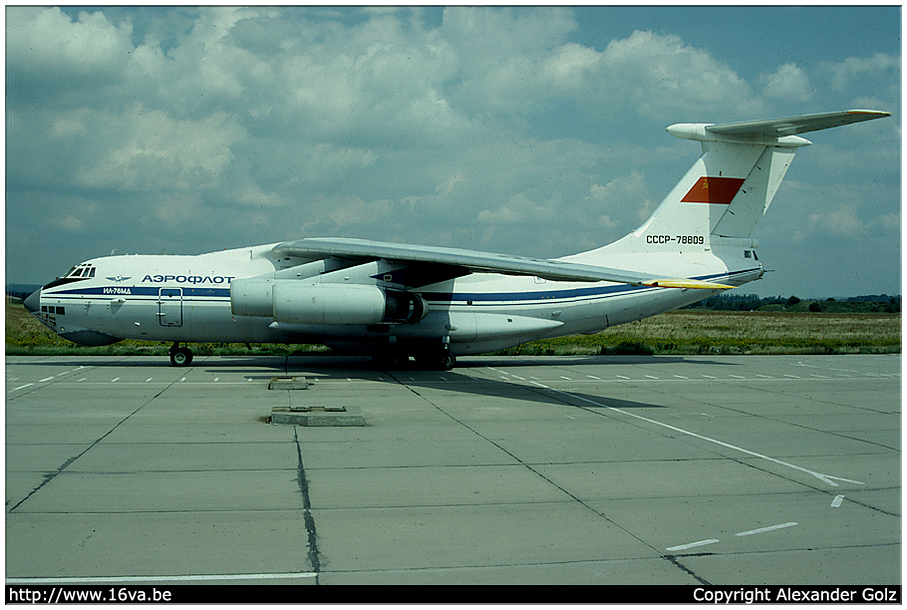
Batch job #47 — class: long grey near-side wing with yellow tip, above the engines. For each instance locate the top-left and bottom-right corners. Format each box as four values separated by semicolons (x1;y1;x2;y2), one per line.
274;237;733;290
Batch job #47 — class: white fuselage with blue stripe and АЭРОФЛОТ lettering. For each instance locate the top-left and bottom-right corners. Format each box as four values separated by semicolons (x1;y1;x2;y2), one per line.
28;242;762;355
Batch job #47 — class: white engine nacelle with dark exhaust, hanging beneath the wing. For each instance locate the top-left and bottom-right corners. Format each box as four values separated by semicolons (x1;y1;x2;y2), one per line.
230;279;428;325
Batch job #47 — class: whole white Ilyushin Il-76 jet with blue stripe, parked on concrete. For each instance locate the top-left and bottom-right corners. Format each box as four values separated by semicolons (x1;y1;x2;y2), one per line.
25;110;889;369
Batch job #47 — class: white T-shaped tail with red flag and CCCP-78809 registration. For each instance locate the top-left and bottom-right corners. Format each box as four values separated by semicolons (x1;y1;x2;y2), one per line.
626;110;889;252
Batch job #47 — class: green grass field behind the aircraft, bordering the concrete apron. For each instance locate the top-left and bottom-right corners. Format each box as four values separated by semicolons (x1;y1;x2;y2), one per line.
6;299;901;355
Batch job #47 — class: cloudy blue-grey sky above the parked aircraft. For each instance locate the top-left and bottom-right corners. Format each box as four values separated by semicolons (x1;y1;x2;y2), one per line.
5;5;901;298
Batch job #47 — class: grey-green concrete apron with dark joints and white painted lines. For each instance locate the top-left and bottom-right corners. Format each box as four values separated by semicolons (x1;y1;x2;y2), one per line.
6;355;901;585
